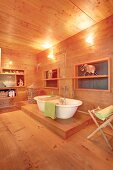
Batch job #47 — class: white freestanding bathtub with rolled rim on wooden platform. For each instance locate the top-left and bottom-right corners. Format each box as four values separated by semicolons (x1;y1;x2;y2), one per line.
34;95;82;119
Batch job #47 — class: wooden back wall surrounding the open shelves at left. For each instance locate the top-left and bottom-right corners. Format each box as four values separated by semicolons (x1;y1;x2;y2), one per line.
2;48;38;102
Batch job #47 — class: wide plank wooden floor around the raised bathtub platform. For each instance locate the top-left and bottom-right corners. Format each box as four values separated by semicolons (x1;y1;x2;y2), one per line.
0;110;113;170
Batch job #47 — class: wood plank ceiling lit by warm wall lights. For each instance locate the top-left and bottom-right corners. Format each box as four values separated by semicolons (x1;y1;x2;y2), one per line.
0;0;113;53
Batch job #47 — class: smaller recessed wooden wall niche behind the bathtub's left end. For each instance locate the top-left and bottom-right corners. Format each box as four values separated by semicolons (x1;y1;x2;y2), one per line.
44;69;59;88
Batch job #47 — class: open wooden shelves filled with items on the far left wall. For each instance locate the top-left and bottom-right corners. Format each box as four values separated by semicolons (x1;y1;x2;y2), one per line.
0;69;25;103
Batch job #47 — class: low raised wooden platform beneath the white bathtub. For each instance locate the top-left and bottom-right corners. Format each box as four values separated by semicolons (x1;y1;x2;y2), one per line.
21;104;91;139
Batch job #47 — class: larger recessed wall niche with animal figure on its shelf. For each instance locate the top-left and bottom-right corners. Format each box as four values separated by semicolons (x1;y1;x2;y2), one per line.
74;58;110;91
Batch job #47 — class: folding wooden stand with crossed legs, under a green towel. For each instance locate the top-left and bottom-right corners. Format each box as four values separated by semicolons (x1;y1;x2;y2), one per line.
87;107;113;150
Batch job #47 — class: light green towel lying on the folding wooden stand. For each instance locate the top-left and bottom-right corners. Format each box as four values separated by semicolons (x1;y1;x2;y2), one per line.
95;105;113;121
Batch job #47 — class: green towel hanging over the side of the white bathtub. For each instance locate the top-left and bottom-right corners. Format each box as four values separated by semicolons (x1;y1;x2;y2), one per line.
44;102;56;119
